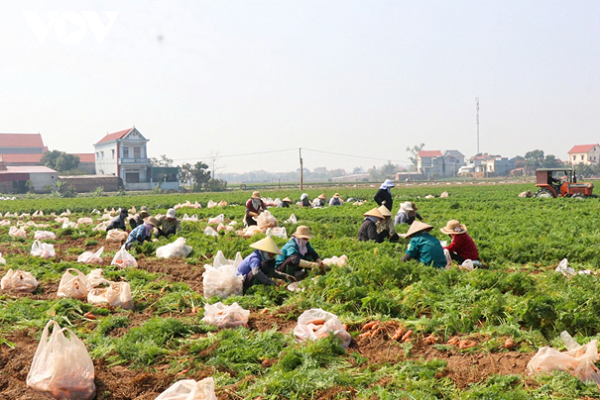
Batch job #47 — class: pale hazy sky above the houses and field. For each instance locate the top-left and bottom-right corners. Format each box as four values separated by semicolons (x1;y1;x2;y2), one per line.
0;0;600;172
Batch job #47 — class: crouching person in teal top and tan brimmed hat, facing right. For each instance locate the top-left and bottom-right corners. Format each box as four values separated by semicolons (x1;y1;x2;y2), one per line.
275;225;323;279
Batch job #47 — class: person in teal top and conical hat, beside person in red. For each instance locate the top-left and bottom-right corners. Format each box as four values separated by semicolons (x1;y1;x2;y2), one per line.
400;221;447;268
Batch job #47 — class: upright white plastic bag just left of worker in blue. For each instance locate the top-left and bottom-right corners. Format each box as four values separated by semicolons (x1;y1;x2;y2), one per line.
202;250;244;299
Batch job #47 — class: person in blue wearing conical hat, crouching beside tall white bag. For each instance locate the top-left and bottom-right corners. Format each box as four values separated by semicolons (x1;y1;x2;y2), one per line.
236;236;296;292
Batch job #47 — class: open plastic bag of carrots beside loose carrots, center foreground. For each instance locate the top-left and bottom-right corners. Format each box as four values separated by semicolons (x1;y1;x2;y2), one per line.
294;308;352;348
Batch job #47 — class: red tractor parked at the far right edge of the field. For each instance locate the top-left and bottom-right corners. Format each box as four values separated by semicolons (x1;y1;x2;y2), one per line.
533;167;594;199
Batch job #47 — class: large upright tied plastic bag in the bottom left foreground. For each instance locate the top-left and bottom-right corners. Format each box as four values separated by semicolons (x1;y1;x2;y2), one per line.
27;320;96;400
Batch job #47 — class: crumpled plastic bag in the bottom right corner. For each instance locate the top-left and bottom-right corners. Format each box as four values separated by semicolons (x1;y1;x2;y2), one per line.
527;331;600;385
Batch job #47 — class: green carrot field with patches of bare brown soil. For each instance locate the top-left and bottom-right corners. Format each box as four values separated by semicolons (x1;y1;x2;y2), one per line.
0;184;600;400
